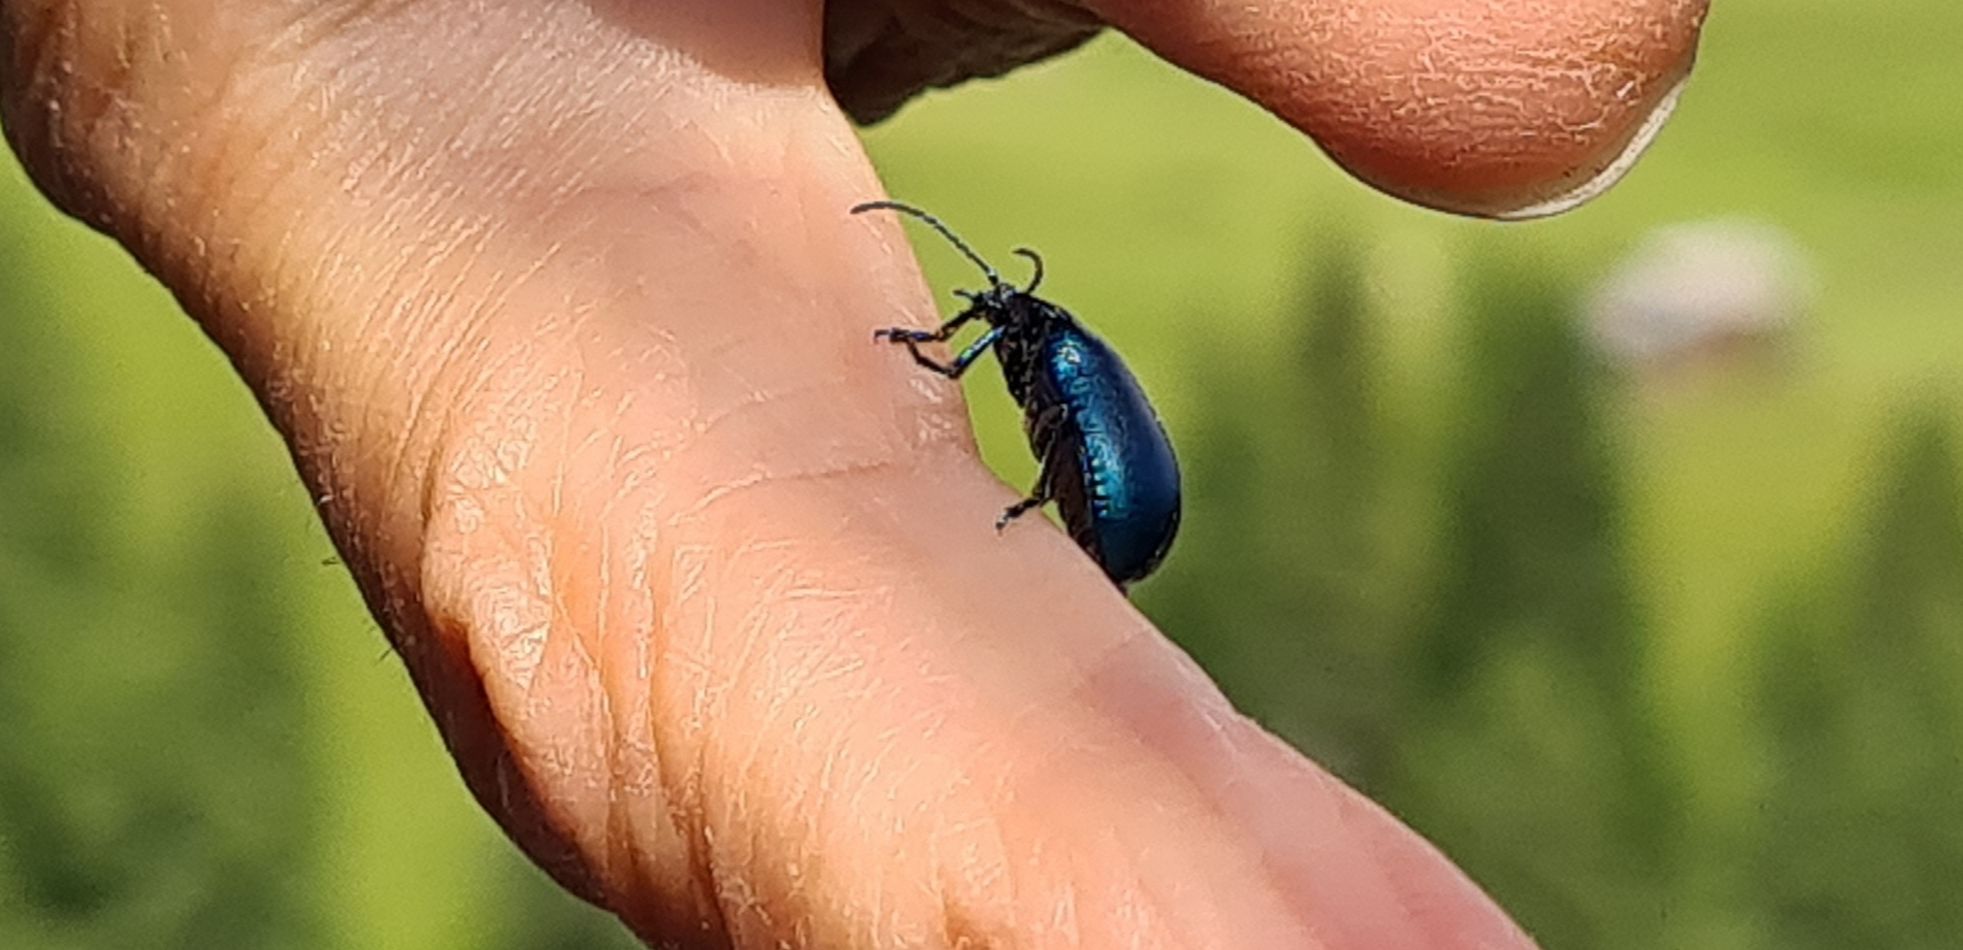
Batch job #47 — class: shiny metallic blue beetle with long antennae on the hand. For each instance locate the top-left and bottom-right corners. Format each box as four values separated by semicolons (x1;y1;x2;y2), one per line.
852;202;1180;589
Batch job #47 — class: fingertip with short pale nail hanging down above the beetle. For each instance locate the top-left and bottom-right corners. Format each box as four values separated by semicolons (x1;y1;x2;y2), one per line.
1091;0;1708;218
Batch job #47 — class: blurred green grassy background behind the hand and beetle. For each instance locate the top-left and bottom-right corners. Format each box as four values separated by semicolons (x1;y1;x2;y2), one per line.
0;0;1963;948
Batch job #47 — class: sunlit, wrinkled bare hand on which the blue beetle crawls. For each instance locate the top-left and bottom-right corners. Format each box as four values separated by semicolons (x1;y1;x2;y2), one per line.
0;0;1704;950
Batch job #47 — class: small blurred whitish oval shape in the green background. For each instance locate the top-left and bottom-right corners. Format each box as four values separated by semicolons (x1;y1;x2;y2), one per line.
1588;220;1814;367
